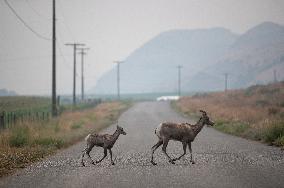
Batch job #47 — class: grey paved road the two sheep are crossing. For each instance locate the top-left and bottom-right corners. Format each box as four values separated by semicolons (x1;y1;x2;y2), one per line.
0;102;284;188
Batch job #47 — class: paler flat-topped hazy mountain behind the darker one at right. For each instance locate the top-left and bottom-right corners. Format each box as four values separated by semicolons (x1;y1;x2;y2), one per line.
91;28;237;94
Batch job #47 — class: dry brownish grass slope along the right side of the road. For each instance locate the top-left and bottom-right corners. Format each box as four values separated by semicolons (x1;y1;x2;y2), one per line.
173;82;284;147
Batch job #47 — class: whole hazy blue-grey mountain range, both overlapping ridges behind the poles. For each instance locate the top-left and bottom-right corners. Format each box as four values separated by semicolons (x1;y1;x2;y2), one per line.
90;22;284;94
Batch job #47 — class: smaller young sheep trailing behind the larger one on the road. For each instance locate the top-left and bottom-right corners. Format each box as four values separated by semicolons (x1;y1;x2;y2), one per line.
81;125;126;166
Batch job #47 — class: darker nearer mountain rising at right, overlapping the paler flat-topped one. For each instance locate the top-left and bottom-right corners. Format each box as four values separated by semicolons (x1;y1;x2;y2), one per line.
189;22;284;90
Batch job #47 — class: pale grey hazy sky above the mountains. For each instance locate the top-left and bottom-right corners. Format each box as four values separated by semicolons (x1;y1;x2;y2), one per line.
0;0;284;95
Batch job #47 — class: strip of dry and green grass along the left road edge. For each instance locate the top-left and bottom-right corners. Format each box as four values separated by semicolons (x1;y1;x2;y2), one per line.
0;102;131;177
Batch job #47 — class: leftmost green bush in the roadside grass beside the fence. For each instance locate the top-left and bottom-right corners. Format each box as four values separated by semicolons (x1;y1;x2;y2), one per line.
9;127;29;147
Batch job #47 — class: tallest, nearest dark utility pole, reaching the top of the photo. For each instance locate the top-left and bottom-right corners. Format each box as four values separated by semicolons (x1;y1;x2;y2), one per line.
51;0;57;117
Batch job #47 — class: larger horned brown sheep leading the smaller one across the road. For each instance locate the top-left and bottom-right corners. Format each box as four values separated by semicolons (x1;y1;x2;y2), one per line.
151;110;214;165
